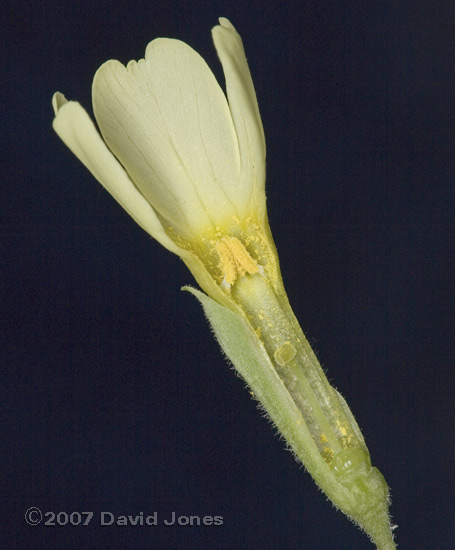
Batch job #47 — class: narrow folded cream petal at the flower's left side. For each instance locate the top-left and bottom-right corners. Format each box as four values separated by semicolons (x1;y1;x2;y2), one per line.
52;92;182;255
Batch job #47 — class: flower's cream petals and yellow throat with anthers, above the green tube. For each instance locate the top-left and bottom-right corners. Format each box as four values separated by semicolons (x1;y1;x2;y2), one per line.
53;18;281;307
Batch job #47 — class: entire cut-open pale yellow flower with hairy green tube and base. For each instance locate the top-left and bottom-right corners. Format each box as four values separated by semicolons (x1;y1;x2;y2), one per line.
53;18;395;550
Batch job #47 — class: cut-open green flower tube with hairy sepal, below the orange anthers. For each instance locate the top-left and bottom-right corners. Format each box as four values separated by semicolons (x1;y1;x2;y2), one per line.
185;272;395;550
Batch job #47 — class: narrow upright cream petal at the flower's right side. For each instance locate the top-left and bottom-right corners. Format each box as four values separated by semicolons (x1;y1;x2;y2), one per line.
212;17;266;217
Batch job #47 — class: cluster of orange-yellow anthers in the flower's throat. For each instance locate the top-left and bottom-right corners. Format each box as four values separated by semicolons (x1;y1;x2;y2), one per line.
215;236;259;285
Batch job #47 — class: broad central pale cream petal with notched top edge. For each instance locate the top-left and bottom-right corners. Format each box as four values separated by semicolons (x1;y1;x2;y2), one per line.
93;38;251;238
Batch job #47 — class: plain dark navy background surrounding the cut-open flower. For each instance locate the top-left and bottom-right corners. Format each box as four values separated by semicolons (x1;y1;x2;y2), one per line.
1;0;455;550
